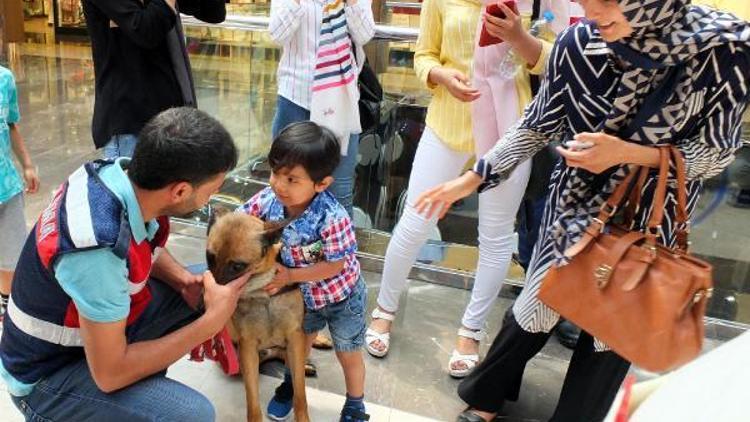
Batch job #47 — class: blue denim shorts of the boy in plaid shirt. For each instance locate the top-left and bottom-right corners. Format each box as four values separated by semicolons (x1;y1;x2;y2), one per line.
302;277;367;352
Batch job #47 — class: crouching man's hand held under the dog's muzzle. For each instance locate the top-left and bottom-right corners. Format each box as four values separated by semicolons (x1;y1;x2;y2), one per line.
203;271;250;332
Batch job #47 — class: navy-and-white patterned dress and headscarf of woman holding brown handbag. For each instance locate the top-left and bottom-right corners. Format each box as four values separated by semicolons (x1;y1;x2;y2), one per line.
474;4;750;350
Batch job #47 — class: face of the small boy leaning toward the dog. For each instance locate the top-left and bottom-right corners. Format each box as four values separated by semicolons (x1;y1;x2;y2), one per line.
271;165;333;211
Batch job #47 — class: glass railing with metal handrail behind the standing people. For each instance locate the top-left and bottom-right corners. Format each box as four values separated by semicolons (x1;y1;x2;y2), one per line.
170;13;750;332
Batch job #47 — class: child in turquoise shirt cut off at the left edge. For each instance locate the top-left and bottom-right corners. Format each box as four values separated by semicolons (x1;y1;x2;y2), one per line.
0;66;39;324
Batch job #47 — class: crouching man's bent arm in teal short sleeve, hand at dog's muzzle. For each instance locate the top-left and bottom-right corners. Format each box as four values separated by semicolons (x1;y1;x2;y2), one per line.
54;248;247;392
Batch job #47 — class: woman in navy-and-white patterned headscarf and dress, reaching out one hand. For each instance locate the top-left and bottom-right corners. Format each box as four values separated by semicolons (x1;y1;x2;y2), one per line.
417;0;750;422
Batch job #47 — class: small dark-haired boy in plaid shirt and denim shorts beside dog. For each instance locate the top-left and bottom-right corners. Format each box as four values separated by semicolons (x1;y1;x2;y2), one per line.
240;122;369;422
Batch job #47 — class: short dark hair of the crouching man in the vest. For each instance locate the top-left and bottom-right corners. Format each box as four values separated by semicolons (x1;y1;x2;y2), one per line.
128;107;237;190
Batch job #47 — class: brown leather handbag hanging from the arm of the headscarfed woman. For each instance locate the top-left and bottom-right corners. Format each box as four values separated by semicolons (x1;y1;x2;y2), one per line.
539;147;713;371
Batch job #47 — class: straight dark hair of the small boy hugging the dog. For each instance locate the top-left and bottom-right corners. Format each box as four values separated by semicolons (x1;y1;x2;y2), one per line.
268;122;341;183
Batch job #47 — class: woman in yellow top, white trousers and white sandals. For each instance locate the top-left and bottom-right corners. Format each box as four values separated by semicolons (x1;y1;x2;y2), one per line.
365;0;569;377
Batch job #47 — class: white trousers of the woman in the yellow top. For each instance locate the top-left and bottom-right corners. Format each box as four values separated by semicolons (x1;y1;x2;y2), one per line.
378;127;531;330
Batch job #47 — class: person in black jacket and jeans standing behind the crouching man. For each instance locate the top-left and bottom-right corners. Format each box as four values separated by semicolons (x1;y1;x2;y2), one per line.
83;0;226;158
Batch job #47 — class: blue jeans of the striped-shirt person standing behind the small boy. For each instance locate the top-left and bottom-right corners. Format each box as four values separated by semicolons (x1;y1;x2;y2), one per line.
271;95;359;218
